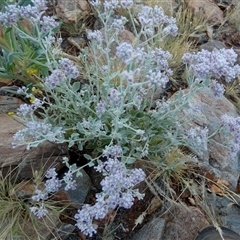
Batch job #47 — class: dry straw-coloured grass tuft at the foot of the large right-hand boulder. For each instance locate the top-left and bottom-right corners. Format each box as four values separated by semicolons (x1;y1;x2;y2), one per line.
148;148;199;202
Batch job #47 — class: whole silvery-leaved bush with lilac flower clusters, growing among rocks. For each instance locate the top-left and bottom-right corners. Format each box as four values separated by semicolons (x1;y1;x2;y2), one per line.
6;0;240;235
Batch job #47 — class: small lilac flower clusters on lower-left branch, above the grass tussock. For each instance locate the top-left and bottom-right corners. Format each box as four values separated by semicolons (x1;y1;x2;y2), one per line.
30;168;76;218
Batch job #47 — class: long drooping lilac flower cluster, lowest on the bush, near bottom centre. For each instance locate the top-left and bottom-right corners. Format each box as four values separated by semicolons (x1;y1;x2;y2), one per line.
75;145;145;236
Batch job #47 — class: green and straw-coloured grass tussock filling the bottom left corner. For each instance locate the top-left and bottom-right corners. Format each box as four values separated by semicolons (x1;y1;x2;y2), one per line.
0;165;63;240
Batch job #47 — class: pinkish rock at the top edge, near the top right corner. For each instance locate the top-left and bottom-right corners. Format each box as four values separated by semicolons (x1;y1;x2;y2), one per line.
185;0;223;24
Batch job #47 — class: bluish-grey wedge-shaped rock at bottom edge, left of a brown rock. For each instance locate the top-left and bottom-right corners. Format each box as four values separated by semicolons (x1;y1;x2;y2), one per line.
130;218;167;240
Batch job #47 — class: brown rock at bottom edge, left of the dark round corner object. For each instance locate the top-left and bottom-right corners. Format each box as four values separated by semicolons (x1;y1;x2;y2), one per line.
161;206;209;240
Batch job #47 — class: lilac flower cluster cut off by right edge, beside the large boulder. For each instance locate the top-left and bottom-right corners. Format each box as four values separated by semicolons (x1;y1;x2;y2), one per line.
221;114;240;160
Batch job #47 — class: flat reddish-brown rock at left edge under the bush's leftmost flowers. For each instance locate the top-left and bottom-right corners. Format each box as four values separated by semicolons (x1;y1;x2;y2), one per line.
0;114;68;179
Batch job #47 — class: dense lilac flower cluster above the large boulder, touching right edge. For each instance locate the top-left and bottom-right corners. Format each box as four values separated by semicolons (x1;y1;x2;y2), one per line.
182;49;240;83
